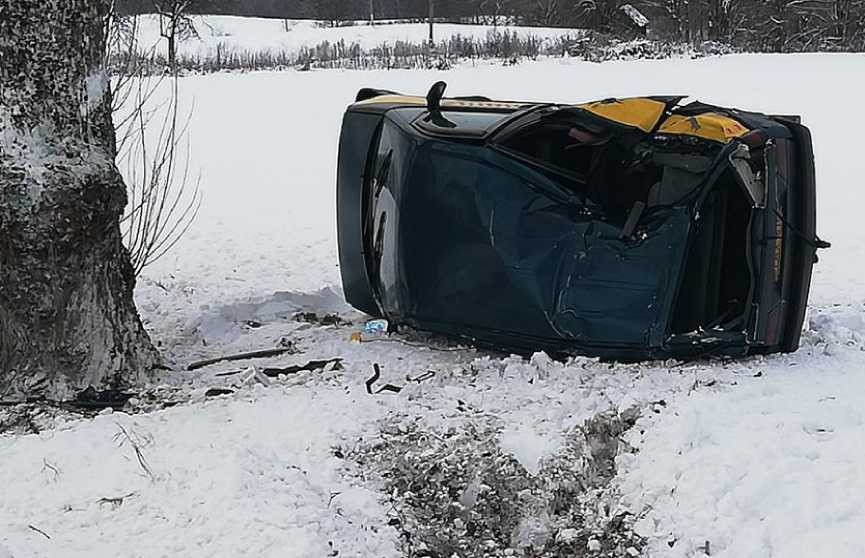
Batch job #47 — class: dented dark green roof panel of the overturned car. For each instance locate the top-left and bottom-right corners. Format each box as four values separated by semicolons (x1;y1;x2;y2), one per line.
383;142;689;347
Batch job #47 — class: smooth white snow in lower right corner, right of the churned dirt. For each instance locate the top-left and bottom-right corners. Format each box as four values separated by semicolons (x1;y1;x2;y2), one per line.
622;332;865;558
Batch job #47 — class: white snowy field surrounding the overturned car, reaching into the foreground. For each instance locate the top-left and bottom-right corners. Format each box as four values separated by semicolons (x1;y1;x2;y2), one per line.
0;48;865;558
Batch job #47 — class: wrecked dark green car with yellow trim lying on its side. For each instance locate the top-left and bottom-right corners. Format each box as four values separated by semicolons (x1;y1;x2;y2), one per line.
337;82;824;360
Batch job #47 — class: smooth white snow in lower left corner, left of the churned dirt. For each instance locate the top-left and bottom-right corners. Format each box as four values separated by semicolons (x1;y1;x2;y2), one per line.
0;386;398;558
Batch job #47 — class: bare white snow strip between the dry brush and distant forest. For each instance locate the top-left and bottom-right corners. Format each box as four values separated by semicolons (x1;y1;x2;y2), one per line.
138;15;580;58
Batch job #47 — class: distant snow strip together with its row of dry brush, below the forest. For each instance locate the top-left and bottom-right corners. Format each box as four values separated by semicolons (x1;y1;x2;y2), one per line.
123;15;730;72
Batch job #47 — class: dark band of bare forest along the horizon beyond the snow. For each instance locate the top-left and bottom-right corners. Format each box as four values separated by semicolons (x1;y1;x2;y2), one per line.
118;0;865;52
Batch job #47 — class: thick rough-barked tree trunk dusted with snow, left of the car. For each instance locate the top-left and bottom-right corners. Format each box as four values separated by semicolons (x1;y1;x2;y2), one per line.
0;0;158;399
